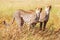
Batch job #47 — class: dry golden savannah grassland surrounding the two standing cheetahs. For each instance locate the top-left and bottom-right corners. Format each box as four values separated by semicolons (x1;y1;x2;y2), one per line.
0;0;60;40
